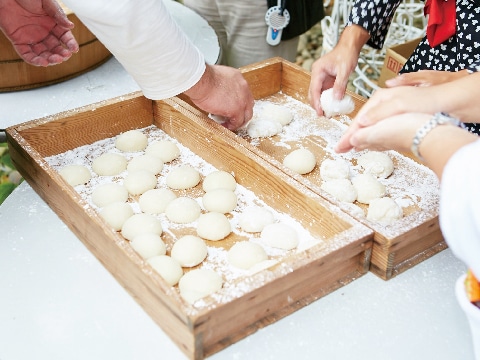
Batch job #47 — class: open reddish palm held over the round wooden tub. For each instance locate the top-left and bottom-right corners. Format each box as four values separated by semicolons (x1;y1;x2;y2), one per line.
0;0;79;66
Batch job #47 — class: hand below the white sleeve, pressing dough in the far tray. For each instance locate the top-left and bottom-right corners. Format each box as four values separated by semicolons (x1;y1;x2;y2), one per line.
185;65;254;131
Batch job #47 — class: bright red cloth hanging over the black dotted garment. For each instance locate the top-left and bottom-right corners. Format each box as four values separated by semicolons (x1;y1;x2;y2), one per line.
423;0;457;48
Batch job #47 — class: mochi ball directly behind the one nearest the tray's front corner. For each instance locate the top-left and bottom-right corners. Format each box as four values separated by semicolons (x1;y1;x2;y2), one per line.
170;235;208;267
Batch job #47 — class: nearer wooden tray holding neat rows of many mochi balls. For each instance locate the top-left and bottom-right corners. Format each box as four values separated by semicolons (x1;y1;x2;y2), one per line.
7;93;373;359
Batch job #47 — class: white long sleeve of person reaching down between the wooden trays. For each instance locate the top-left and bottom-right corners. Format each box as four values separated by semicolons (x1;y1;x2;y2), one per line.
62;0;205;100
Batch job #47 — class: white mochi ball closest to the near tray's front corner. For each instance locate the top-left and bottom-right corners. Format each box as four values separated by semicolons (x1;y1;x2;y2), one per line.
178;269;223;304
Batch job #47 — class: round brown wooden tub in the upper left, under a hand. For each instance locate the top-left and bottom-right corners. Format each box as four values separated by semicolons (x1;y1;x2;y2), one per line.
0;7;112;92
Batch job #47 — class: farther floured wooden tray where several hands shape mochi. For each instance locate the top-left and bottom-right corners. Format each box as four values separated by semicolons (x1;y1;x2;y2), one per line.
188;58;447;280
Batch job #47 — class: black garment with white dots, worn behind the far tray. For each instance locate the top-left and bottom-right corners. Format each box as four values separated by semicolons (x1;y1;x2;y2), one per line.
347;0;480;134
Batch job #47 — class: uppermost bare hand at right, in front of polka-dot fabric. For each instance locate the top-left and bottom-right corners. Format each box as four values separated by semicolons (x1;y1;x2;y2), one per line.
385;70;468;88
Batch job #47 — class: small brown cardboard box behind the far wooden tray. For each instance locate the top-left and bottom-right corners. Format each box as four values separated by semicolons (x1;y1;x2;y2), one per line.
378;38;422;87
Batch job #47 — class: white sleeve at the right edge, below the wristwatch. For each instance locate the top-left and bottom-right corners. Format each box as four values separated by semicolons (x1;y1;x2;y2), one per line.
440;140;480;278
